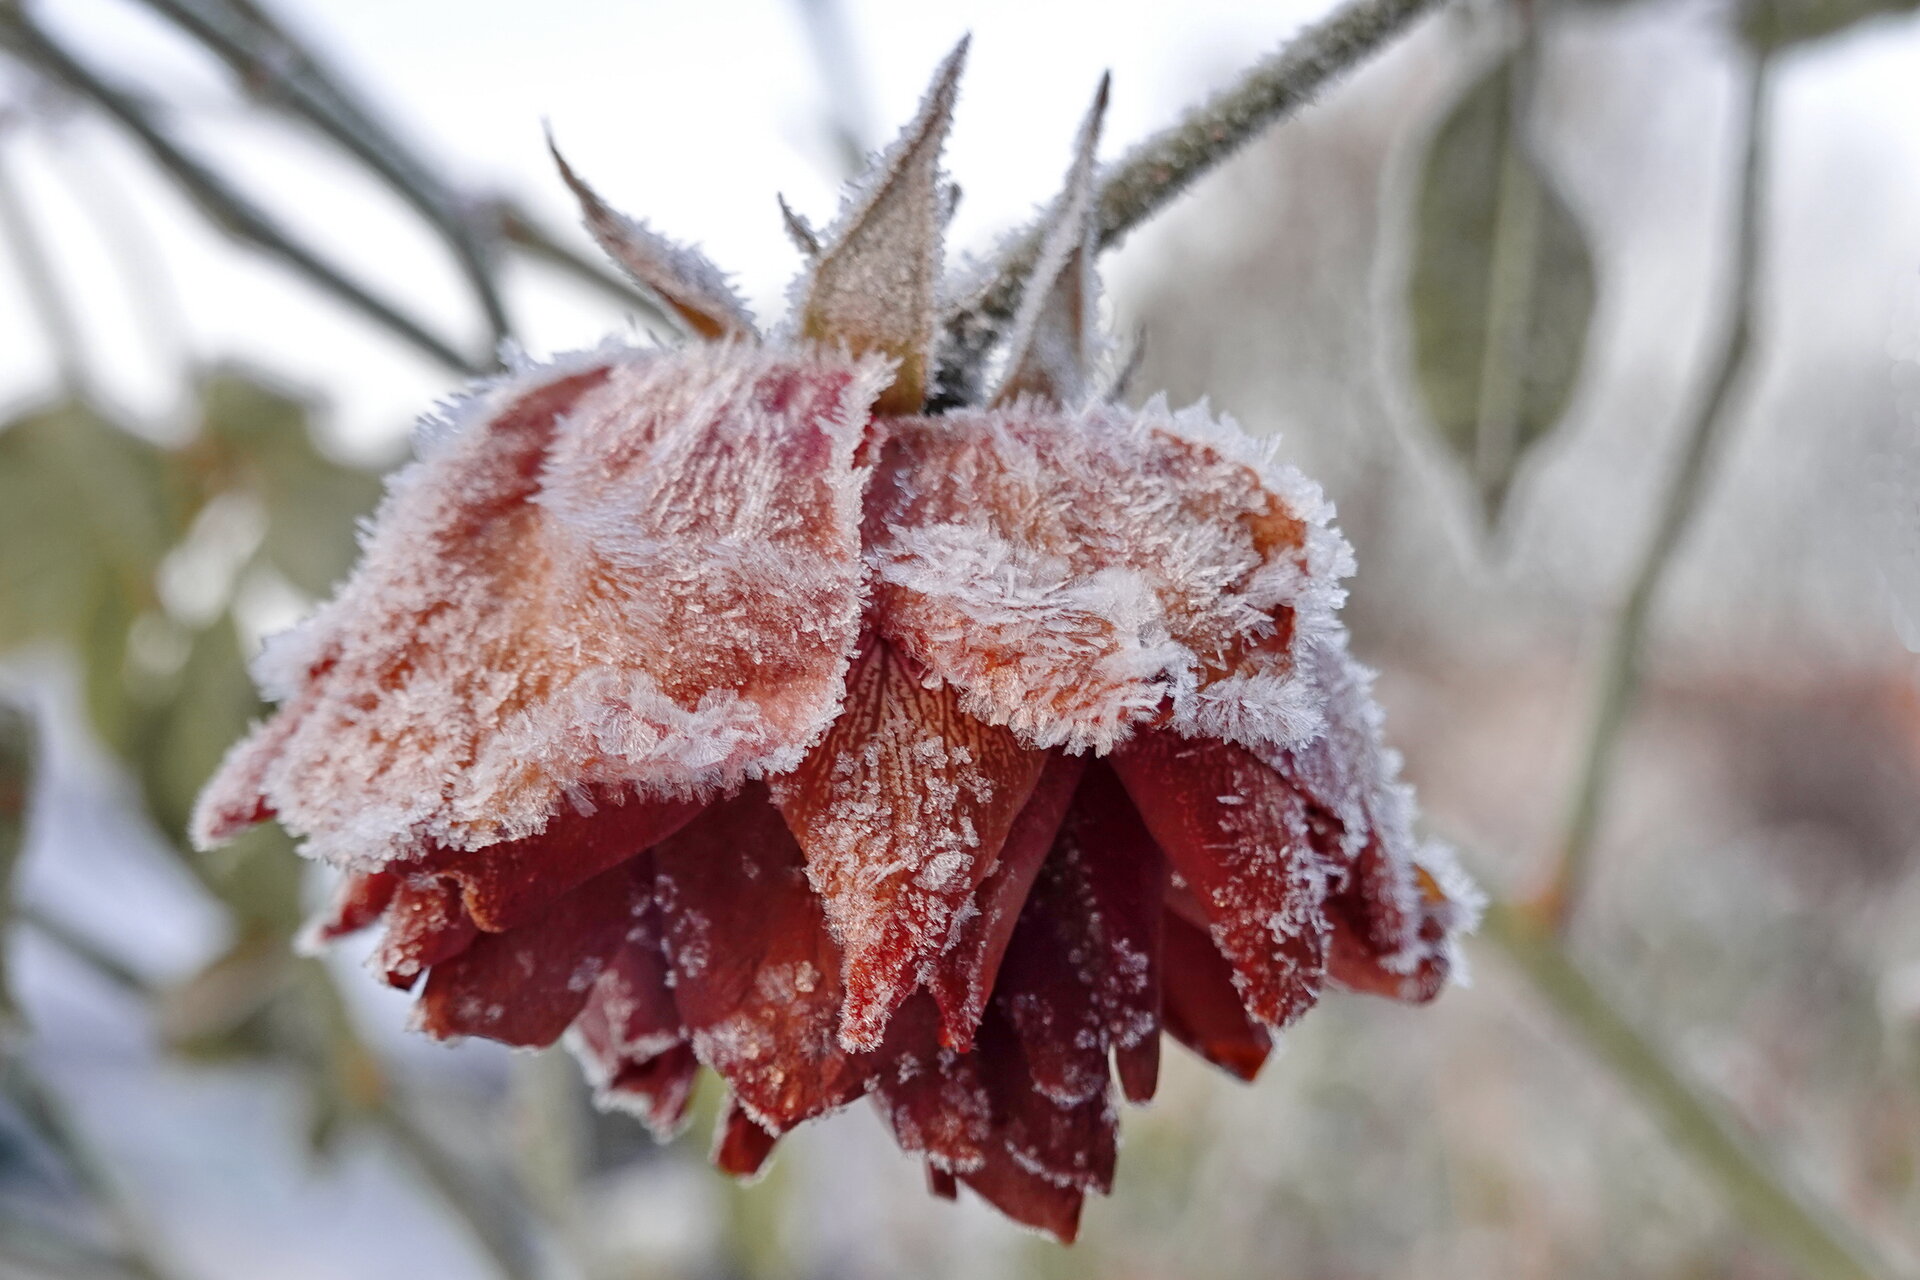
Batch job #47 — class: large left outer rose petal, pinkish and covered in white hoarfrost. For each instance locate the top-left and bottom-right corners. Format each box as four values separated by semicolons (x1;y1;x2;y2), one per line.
198;345;887;867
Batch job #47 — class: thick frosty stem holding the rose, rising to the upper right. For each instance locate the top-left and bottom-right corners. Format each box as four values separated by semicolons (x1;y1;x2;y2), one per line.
936;0;1442;364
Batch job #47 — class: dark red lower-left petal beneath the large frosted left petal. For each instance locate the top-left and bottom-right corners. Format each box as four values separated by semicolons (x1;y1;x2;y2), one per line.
415;865;645;1048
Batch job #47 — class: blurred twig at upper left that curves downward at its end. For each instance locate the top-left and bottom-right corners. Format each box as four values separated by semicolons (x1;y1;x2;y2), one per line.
130;0;511;345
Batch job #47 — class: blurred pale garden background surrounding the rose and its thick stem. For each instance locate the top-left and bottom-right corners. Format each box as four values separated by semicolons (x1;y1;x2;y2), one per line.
0;0;1920;1280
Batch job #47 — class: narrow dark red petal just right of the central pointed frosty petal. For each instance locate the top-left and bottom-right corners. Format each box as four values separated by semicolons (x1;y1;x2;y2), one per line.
927;752;1090;1050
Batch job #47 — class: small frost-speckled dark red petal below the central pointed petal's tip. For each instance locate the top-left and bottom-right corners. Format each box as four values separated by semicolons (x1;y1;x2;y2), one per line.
874;992;998;1173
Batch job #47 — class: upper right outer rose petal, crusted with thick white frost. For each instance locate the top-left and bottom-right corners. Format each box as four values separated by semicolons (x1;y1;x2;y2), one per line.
866;401;1346;752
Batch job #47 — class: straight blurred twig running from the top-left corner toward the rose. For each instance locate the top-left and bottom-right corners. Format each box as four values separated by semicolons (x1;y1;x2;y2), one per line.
0;6;480;374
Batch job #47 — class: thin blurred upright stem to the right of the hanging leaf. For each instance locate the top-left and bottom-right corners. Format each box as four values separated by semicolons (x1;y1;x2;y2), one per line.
1538;52;1770;929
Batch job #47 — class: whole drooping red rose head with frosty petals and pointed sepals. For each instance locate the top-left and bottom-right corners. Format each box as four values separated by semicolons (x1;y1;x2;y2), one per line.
194;50;1473;1240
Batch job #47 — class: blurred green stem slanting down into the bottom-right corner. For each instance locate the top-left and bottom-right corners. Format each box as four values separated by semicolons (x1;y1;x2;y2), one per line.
1480;902;1903;1280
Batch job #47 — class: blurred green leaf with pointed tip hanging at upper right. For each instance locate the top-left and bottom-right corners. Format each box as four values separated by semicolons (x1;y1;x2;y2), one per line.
1407;56;1594;522
